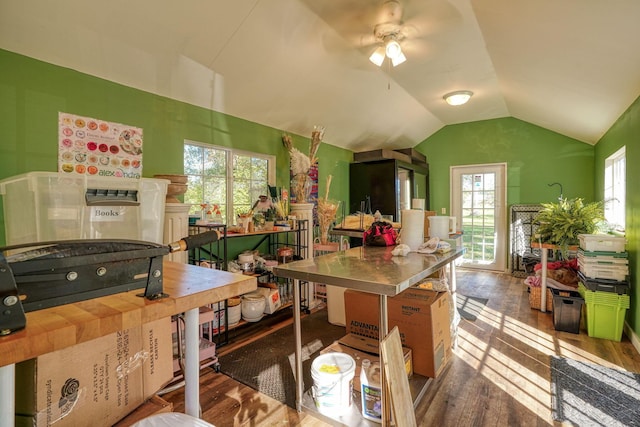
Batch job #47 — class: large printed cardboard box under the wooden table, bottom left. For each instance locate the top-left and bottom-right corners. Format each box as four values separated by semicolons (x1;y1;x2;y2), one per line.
16;318;173;427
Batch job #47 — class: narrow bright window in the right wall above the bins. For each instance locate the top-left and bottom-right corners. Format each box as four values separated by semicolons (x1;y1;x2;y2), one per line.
604;147;627;231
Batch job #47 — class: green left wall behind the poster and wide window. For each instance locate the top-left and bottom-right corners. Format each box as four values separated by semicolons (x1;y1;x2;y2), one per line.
0;49;353;249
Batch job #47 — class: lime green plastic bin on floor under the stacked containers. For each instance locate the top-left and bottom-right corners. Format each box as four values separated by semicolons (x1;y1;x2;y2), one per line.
578;283;630;341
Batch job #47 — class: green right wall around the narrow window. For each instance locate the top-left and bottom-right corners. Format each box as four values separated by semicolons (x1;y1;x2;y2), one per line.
595;98;640;334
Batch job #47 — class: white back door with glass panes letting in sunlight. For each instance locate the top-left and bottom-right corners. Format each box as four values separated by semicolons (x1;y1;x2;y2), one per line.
451;163;507;271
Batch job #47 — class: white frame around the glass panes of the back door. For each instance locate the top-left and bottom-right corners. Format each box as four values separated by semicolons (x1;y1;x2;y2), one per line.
449;163;508;272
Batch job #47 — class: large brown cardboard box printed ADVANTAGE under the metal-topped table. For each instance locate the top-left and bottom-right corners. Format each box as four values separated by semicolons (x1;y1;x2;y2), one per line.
344;288;452;378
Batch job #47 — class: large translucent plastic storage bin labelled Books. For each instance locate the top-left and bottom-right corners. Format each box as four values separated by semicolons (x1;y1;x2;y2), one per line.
0;172;169;245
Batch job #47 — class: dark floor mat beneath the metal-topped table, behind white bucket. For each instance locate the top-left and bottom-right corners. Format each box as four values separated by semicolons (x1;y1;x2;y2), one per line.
219;310;345;409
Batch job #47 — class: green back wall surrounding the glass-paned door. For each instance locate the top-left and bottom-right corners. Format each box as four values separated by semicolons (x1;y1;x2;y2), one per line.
416;118;594;212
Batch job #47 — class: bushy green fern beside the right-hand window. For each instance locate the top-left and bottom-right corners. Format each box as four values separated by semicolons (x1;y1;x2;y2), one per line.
533;198;604;255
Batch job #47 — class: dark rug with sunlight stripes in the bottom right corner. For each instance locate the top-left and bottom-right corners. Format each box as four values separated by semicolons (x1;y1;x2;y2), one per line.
551;356;640;427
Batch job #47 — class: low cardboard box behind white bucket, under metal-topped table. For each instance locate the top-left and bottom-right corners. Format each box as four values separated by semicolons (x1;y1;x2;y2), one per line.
320;334;413;392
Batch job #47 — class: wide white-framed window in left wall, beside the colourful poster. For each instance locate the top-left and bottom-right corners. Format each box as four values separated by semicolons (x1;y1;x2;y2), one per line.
184;141;276;224
